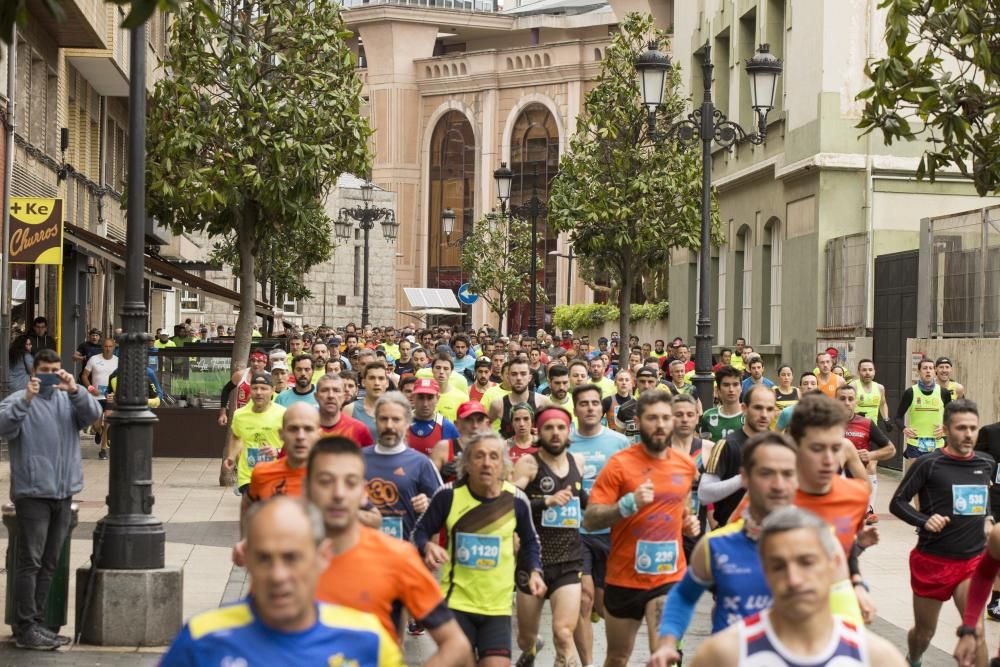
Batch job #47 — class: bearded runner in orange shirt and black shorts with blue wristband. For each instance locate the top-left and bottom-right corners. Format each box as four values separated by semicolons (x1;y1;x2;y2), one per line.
583;389;699;667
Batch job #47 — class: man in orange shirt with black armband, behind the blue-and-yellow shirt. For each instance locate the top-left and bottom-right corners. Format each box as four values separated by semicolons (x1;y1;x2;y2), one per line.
306;437;472;665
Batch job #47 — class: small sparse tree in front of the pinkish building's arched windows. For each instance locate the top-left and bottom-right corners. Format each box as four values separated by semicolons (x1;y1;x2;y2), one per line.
462;215;545;327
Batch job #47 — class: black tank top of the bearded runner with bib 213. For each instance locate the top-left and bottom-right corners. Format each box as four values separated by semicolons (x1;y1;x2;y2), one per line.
524;452;583;567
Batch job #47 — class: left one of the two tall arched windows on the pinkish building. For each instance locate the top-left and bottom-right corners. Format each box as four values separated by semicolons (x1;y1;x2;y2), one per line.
427;111;476;290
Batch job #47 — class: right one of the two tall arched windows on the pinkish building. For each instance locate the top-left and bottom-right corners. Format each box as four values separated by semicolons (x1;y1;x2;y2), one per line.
510;104;559;333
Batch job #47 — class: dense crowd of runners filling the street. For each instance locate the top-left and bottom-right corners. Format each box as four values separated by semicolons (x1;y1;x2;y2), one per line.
148;325;1000;667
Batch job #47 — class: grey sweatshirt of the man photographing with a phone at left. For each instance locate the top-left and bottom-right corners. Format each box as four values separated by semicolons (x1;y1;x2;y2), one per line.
0;387;101;500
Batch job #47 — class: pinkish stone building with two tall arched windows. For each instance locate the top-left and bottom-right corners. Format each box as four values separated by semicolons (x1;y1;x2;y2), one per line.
345;0;617;329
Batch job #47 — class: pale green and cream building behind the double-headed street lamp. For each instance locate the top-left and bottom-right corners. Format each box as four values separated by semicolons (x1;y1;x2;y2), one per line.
670;0;1000;370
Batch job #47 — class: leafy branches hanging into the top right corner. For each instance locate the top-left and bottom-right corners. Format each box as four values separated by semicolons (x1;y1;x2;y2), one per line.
858;0;1000;196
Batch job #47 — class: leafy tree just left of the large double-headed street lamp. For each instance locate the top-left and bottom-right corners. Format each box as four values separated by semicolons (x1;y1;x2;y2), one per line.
548;13;719;350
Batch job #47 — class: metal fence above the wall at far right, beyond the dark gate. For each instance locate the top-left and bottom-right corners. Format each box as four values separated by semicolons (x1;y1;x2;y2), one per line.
919;206;1000;338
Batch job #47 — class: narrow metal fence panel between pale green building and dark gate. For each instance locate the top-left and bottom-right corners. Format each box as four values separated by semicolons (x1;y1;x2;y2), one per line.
826;234;868;327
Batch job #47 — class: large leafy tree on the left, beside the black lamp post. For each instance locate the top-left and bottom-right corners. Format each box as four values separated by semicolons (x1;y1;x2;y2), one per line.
147;0;370;364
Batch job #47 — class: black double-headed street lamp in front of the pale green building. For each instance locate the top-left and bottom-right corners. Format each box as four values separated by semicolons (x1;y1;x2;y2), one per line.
635;42;782;402
